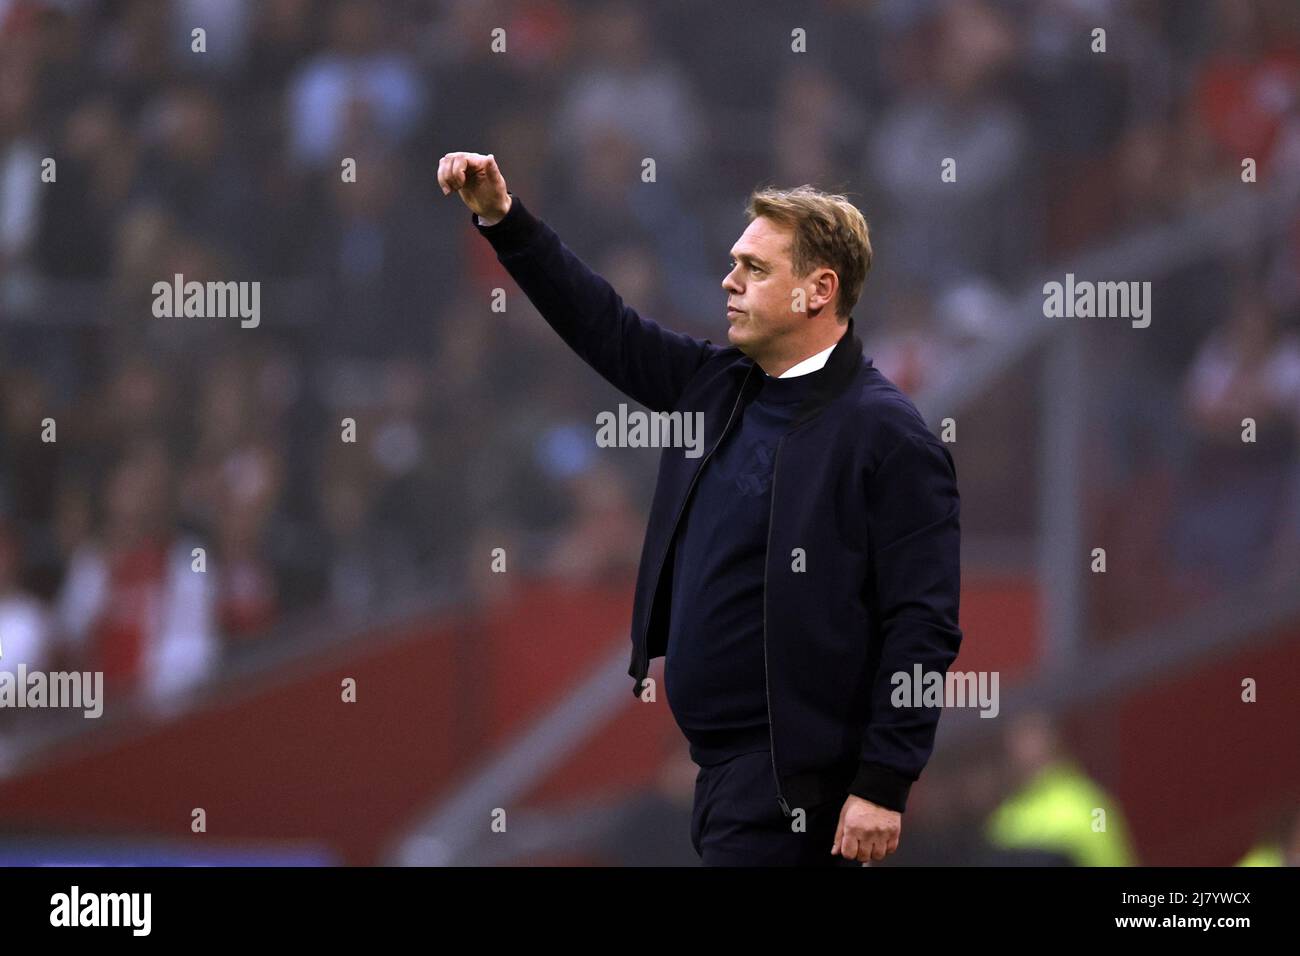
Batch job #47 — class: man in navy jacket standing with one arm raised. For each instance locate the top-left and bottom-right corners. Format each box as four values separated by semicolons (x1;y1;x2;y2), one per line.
438;152;961;865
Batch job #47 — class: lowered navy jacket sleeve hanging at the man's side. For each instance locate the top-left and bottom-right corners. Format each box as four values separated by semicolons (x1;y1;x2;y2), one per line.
849;433;962;813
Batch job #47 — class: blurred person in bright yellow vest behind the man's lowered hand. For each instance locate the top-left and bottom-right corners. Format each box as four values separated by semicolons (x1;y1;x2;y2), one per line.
984;713;1136;866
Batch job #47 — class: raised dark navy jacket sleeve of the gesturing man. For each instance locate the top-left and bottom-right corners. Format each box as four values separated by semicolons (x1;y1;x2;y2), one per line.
469;193;722;411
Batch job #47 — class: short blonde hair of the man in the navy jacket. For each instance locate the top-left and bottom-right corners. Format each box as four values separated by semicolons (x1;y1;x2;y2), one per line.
745;185;871;321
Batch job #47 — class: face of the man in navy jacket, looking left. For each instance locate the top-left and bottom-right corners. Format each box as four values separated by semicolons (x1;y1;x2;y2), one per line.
723;216;811;362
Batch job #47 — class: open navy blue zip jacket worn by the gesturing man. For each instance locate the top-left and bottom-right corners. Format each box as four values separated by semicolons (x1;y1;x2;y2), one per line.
471;194;962;816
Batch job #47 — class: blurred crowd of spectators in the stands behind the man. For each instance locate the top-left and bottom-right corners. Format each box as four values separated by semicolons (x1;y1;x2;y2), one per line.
0;0;1300;695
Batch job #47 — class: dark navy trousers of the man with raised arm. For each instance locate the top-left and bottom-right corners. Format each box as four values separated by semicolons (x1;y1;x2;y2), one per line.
690;750;862;866
